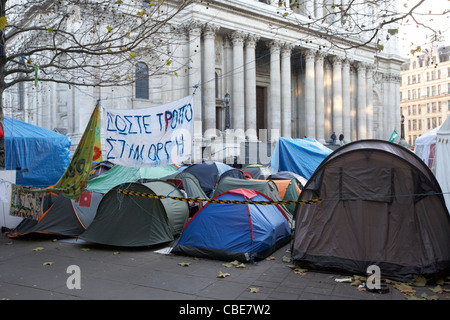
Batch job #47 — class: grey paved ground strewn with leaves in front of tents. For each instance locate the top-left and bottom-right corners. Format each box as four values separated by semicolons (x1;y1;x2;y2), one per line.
0;233;450;313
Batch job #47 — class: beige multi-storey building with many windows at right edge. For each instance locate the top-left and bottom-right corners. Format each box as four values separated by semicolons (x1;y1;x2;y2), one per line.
400;46;450;146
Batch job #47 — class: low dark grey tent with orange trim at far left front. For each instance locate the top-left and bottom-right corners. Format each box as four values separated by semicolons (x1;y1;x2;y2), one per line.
8;191;103;238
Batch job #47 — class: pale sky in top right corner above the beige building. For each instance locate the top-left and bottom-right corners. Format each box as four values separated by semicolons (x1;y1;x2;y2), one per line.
399;0;450;58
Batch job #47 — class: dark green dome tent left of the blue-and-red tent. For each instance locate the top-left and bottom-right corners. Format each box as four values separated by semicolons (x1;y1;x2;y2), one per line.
79;181;189;247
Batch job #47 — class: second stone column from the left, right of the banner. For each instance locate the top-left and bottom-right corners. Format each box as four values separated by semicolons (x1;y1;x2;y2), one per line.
203;23;219;139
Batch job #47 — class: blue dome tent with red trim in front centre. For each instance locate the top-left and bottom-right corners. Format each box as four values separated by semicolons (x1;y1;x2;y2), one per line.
172;189;291;262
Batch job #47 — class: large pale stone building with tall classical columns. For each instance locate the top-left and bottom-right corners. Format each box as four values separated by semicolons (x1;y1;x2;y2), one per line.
5;0;403;164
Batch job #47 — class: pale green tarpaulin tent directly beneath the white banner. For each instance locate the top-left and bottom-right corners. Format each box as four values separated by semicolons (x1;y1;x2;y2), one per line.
86;165;177;193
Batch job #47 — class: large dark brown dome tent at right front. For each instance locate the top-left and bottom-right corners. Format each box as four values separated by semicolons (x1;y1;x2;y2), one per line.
292;140;450;281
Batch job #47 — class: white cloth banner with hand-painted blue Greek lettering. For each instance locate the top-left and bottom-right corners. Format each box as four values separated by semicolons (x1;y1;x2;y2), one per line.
102;96;194;167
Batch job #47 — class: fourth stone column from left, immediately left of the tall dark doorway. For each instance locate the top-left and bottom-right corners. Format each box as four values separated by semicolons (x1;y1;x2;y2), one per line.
245;35;259;141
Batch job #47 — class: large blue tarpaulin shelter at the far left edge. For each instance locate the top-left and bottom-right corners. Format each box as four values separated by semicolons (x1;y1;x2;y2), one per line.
4;117;70;188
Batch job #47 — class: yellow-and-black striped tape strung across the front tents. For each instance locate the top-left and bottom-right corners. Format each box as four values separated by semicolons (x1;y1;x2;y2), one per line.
117;189;322;205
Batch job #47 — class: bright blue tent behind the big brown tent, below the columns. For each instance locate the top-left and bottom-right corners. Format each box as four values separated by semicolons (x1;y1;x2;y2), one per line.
270;137;333;179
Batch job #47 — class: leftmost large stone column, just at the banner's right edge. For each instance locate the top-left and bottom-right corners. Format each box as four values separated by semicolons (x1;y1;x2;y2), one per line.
188;21;203;143
